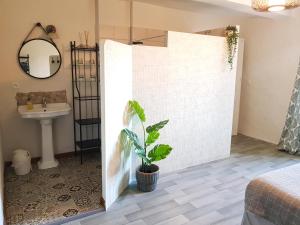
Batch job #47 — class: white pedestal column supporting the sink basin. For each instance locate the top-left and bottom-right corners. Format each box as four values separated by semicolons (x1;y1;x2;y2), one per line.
38;119;58;169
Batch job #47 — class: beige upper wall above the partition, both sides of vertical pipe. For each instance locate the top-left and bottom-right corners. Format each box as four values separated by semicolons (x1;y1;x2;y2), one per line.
99;0;248;33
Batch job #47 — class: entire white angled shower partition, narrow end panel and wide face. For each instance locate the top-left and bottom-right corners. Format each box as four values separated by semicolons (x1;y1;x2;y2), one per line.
100;32;237;207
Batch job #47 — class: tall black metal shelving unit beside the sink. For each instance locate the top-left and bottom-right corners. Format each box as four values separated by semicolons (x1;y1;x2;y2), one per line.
70;41;101;164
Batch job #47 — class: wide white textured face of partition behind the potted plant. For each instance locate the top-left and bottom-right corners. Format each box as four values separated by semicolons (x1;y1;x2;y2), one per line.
133;32;236;173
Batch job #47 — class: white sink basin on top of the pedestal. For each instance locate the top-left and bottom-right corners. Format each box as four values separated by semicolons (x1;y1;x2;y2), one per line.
18;103;71;120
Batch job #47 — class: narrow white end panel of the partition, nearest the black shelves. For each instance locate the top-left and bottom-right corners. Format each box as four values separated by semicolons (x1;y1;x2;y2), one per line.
100;41;132;208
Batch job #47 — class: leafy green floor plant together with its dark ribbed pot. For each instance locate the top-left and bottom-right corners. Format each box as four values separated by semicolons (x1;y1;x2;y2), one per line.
122;101;172;192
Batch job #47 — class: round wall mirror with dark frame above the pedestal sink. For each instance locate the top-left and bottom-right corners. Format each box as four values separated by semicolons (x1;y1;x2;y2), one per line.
18;39;61;79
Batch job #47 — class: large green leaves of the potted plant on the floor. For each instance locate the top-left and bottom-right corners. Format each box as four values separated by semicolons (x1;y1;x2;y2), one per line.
122;100;172;171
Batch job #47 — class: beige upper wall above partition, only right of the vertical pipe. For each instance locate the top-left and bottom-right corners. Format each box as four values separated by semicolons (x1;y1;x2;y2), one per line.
133;1;248;32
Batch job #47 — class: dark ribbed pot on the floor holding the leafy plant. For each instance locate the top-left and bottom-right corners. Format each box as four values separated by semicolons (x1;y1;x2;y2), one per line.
136;164;159;192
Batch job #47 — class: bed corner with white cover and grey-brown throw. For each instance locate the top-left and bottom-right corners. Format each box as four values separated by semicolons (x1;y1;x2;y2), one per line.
242;163;300;225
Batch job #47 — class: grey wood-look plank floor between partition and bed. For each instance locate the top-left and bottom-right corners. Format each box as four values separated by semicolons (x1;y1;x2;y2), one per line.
65;135;300;225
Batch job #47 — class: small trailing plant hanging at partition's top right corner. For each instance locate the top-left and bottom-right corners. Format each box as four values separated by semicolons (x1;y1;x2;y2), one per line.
225;26;240;69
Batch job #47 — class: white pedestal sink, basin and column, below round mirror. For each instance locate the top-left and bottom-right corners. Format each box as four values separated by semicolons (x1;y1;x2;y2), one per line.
18;103;71;169
